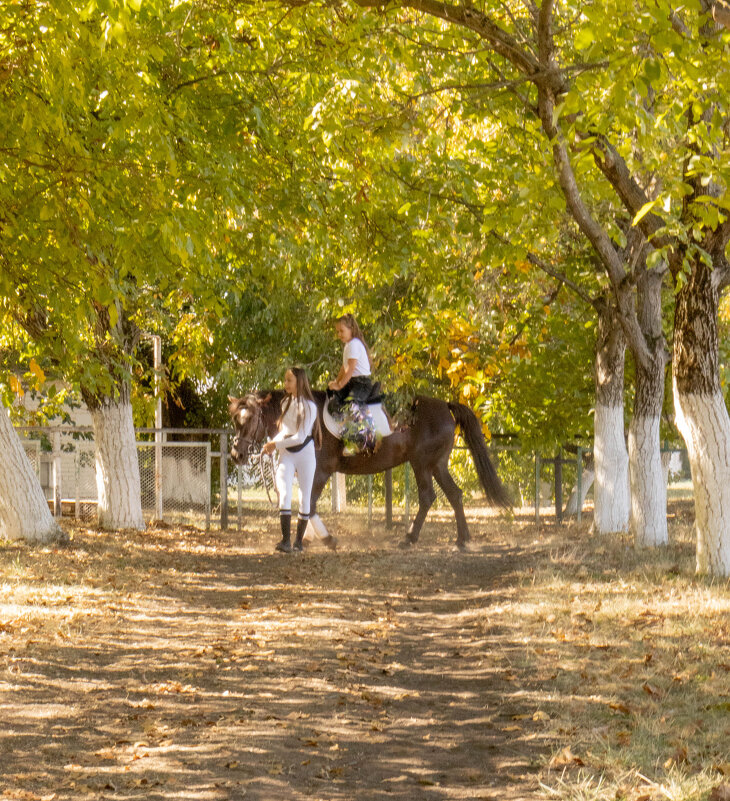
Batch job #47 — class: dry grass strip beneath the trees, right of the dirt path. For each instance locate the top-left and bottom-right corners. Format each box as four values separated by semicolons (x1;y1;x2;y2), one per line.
505;505;730;801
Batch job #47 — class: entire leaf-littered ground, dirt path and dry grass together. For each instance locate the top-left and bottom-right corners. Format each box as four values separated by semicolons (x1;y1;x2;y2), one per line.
0;500;730;801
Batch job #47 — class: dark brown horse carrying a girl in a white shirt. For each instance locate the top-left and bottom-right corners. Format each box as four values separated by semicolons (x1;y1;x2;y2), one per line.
229;390;510;549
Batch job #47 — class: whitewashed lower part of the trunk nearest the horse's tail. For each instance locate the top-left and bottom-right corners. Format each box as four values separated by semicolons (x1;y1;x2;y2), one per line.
593;404;629;534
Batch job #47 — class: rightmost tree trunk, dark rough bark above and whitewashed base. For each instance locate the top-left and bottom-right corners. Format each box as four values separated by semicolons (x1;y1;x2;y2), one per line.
672;260;730;578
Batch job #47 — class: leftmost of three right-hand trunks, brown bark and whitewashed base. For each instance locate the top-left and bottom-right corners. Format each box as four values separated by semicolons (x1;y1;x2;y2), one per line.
593;303;629;534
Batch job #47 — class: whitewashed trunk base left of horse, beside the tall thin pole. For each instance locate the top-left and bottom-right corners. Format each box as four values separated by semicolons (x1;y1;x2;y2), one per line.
91;399;145;529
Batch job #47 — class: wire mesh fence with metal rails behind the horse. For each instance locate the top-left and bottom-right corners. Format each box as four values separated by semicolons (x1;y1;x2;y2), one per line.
17;426;691;529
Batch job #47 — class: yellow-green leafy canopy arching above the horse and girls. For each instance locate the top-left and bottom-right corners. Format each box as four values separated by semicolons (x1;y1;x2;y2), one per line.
0;0;726;444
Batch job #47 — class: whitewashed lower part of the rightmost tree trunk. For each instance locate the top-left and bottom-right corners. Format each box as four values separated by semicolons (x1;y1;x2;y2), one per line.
674;381;730;578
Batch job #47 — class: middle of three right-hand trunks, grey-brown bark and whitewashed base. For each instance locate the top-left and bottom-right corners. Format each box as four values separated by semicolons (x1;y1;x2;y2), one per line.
629;270;669;548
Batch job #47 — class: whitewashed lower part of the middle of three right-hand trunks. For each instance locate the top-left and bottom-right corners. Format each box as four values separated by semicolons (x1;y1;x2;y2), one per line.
629;416;669;548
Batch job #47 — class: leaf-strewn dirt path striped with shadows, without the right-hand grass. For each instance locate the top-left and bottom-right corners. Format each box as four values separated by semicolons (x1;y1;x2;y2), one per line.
0;510;551;801
